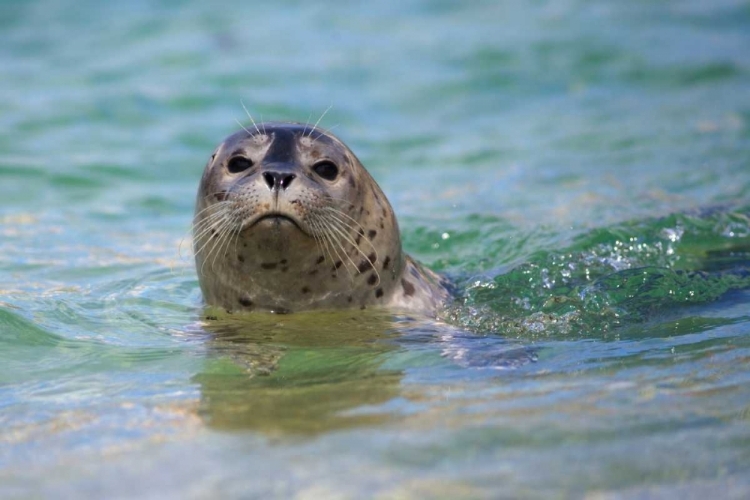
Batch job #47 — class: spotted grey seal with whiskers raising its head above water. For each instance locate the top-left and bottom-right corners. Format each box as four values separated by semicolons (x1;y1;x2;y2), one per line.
193;122;449;316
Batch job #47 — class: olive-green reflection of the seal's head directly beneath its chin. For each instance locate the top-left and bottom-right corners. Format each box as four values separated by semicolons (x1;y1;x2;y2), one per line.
195;311;402;435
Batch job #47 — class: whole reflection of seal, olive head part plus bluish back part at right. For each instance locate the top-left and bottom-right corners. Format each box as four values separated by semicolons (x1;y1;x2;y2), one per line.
194;309;537;435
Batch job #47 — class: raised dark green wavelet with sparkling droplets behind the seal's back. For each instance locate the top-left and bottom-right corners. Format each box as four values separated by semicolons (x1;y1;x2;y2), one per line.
446;205;750;339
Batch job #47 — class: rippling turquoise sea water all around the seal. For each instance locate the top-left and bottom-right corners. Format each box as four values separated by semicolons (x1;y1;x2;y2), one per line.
0;0;750;498
